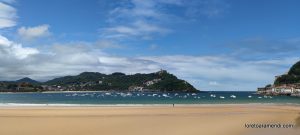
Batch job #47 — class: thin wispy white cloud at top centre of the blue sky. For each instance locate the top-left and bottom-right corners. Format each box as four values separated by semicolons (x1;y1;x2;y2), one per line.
101;0;180;39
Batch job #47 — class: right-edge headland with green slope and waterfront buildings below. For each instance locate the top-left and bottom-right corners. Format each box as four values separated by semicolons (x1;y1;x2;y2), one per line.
257;61;300;97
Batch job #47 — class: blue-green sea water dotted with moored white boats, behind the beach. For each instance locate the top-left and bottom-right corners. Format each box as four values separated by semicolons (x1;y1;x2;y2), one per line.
0;91;300;105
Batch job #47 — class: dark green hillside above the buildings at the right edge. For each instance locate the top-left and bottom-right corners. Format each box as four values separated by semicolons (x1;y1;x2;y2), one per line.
274;61;300;85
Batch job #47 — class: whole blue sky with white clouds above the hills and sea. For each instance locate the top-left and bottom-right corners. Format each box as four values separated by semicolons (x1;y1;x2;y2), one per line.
0;0;300;91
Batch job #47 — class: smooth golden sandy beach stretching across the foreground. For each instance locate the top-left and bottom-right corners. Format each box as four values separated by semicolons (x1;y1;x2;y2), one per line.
0;105;300;135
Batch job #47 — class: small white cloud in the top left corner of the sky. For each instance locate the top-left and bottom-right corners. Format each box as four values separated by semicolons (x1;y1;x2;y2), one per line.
0;1;17;29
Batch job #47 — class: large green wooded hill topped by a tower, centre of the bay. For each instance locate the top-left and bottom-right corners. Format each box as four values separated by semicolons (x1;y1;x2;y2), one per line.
44;70;197;92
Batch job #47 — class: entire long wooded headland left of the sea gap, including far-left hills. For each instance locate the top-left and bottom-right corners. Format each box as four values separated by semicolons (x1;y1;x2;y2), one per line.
0;70;199;92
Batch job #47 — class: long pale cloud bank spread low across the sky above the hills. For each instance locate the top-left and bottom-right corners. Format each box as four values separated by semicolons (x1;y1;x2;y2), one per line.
0;38;299;90
